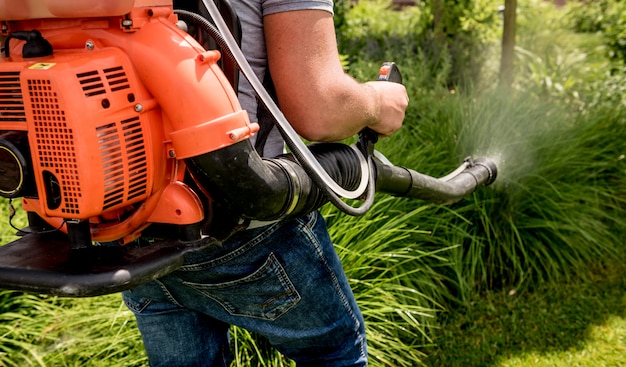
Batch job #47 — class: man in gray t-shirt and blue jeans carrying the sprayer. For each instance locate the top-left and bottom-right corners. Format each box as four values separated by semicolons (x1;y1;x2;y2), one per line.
124;0;408;367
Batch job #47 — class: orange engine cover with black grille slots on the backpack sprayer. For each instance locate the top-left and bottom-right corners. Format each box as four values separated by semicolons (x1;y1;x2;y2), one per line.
5;48;161;220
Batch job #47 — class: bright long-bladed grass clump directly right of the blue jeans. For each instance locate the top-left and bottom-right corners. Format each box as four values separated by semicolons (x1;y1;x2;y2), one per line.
325;197;447;367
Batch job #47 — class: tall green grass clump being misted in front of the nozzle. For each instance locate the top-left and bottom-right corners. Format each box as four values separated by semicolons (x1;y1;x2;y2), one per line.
394;85;626;299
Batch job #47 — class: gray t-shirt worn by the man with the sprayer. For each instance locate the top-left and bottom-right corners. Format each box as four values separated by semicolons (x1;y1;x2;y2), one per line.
231;0;333;157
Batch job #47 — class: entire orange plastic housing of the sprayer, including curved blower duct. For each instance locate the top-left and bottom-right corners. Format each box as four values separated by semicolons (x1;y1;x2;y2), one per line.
0;0;258;242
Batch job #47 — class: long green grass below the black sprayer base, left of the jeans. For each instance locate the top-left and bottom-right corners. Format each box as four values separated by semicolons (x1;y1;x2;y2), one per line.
0;291;147;366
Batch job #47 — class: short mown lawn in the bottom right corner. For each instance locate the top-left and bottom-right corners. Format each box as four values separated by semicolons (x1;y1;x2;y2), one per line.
426;263;626;367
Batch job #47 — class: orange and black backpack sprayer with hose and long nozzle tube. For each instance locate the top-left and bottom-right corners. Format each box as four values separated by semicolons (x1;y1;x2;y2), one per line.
0;0;496;297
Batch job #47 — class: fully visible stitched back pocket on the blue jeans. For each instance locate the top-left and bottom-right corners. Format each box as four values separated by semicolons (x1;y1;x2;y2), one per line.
183;253;300;320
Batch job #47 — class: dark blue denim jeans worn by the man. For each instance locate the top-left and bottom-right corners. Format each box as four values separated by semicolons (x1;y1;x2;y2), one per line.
123;212;367;367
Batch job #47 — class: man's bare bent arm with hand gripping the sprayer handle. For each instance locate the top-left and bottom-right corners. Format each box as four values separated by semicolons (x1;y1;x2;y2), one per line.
264;10;408;141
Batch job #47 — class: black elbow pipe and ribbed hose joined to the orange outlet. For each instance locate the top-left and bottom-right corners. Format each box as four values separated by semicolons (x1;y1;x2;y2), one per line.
186;140;361;221
